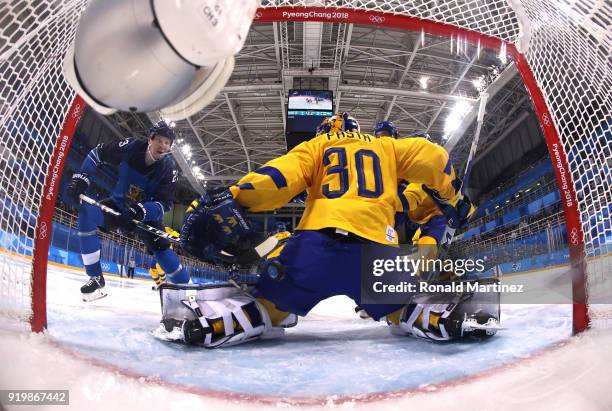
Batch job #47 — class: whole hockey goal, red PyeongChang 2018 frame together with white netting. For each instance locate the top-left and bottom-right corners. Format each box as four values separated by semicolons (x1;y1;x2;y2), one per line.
0;0;612;331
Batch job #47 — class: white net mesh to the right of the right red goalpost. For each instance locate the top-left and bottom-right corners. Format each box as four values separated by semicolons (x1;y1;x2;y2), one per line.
512;1;612;309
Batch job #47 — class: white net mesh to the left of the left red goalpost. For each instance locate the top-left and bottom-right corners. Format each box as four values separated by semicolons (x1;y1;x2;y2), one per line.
0;1;84;326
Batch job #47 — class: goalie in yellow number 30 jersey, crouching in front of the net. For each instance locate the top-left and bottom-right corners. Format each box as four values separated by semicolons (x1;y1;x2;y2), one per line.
162;113;502;347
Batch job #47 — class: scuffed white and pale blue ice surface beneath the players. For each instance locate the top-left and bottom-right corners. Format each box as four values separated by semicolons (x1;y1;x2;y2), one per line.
0;266;612;411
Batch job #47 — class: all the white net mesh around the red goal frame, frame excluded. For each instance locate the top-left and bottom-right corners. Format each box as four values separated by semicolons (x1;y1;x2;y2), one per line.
0;0;612;328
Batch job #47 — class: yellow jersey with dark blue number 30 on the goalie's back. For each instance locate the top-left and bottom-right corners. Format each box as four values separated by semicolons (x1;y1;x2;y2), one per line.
230;132;455;244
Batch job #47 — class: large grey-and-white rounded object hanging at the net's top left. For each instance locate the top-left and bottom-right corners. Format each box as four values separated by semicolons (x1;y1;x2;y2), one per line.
63;0;260;120
